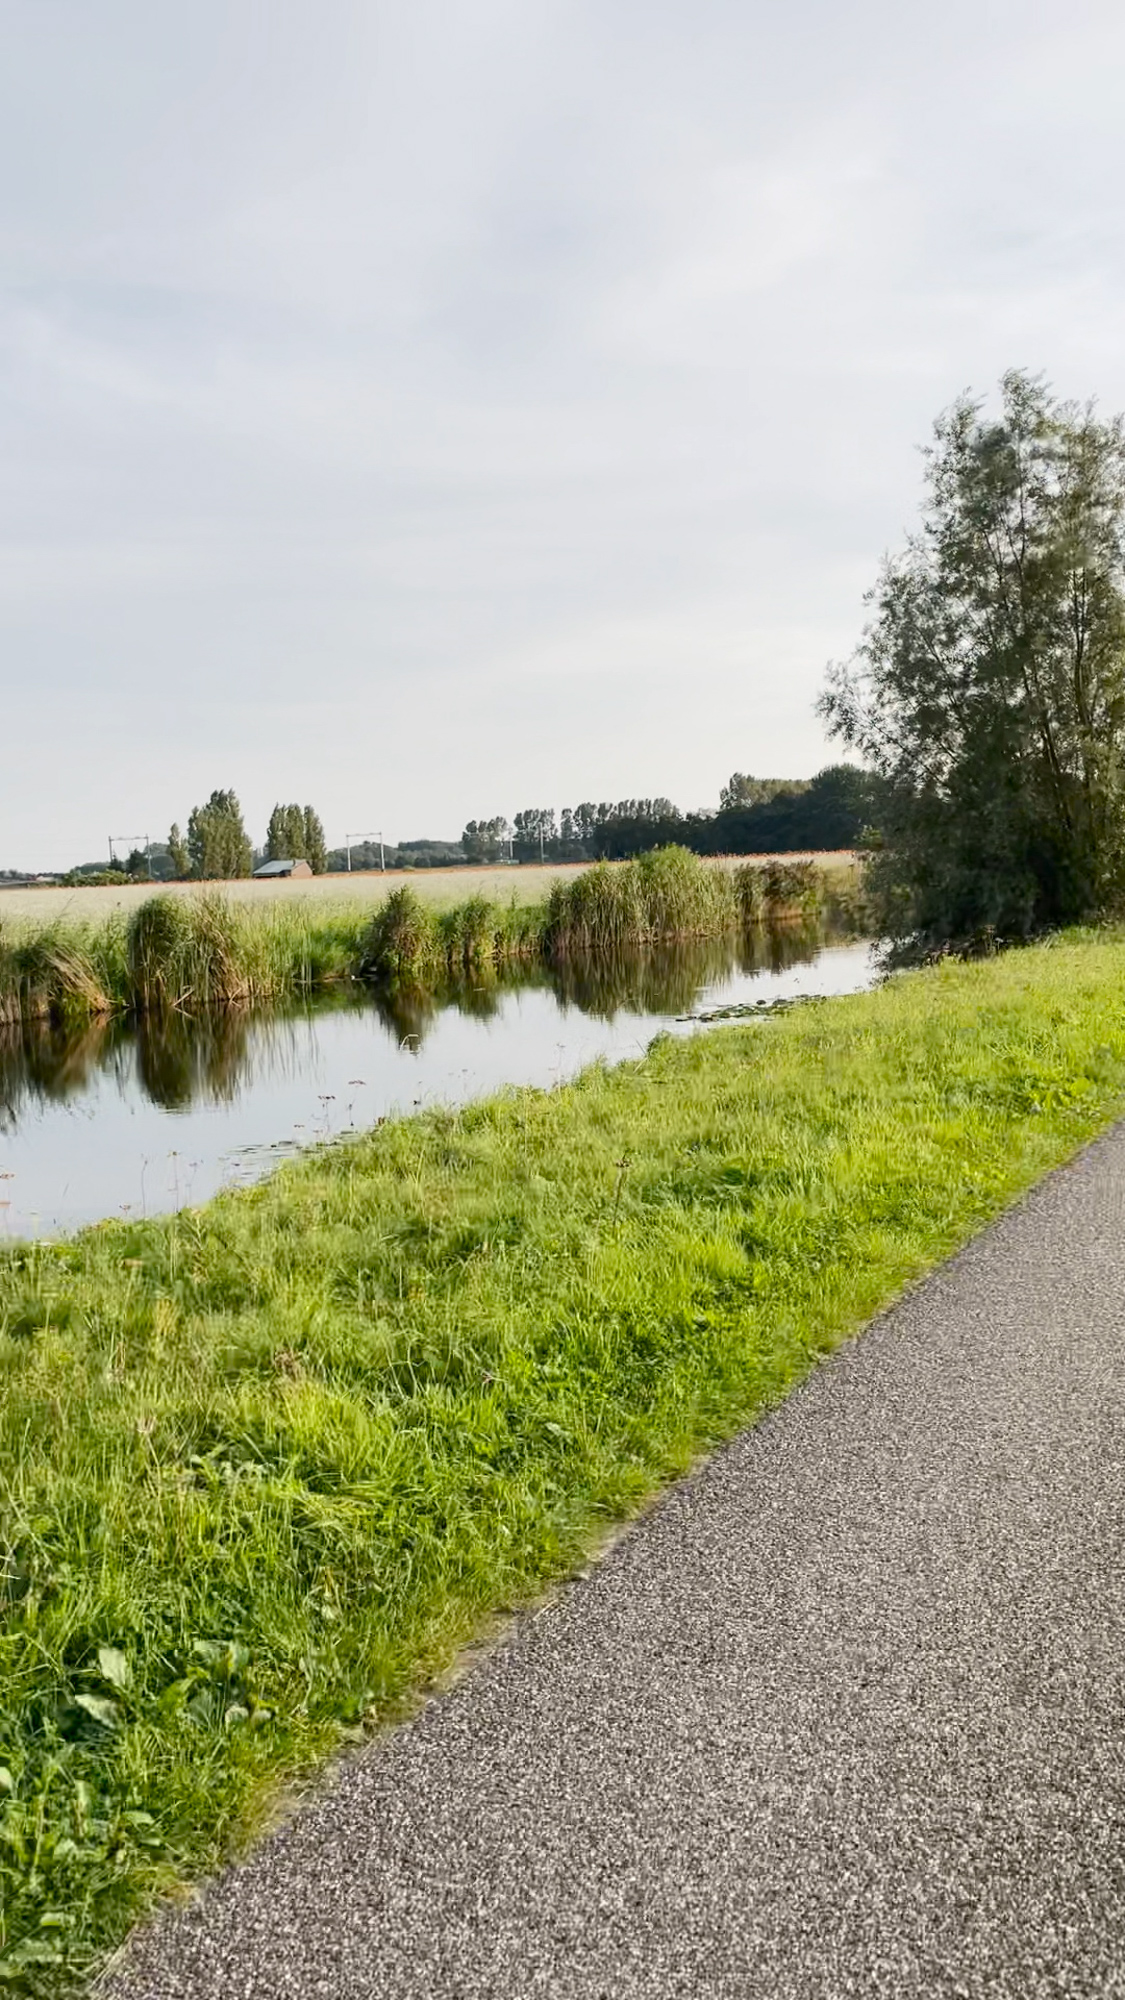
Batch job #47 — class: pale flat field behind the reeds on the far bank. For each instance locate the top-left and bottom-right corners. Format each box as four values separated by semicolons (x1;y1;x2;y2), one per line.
0;848;855;924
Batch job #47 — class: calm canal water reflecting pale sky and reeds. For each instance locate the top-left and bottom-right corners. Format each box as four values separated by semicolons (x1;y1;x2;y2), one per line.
0;930;877;1238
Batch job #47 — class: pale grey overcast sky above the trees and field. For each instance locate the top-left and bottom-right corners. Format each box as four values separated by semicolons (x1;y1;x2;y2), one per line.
0;0;1125;866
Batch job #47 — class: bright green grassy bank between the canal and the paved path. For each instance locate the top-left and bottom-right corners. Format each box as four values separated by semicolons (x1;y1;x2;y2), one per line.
0;936;1125;1994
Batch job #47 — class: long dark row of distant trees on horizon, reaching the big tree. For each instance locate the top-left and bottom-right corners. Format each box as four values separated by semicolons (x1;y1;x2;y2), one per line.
460;764;877;862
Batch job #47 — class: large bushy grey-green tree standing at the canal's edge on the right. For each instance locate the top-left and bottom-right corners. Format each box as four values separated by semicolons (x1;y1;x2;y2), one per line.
821;374;1125;942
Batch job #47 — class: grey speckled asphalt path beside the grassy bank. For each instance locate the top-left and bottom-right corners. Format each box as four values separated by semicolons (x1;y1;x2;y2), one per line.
102;1128;1125;2000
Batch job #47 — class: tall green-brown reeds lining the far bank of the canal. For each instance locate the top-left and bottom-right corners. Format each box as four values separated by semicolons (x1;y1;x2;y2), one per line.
0;848;833;1026
